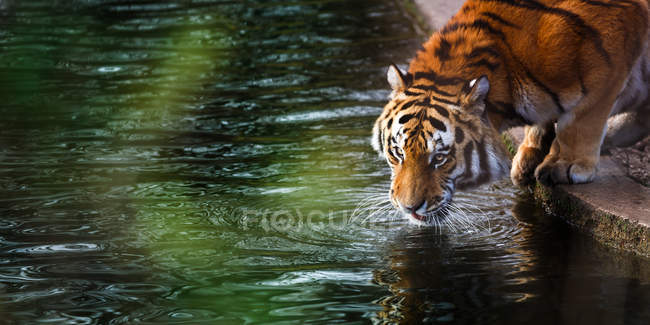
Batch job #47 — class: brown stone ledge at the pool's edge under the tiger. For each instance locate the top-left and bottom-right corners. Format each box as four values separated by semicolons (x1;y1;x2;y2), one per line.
410;0;650;256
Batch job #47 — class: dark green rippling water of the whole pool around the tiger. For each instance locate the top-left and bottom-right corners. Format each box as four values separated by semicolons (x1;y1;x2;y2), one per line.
0;0;650;324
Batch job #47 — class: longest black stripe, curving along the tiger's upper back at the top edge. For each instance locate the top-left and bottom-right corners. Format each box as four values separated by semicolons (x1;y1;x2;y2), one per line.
477;0;612;65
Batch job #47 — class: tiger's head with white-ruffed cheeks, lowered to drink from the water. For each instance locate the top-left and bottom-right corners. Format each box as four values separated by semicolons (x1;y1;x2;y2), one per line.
372;65;510;224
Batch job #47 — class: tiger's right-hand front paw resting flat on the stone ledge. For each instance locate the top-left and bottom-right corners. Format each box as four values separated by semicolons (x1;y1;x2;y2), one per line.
535;157;596;186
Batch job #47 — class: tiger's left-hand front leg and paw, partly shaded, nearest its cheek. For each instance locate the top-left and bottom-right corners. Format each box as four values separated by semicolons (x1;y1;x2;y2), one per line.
510;123;555;187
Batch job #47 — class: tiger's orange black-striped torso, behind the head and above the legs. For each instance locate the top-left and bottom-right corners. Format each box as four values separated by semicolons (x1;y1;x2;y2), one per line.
409;0;648;123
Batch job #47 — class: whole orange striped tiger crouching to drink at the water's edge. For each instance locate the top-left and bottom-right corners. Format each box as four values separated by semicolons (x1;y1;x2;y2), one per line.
372;0;650;224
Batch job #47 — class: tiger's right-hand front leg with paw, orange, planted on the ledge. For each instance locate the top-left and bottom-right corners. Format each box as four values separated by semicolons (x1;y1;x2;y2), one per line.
535;78;623;186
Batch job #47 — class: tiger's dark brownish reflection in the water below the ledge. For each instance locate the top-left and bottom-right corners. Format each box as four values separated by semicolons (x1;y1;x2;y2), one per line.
373;197;650;324
